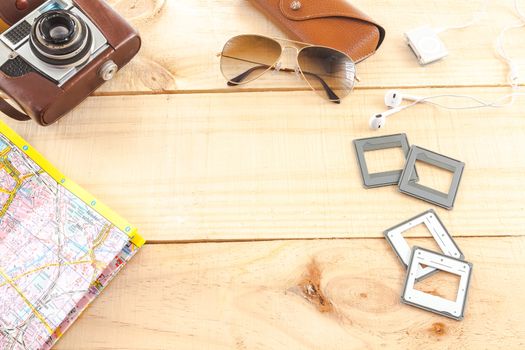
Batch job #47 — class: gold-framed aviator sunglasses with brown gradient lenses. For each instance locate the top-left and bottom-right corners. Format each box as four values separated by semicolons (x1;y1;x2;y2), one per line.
219;35;359;103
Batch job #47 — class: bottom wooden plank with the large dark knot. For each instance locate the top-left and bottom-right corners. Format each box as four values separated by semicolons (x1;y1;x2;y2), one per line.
53;237;525;350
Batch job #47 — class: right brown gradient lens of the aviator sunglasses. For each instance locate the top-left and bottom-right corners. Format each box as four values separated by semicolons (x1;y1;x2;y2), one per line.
297;46;355;102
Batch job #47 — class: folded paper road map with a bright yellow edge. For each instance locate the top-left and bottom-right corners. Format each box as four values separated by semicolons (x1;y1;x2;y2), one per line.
0;121;144;350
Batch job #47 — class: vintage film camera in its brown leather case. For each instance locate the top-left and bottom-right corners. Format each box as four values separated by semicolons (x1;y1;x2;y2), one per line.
0;0;141;125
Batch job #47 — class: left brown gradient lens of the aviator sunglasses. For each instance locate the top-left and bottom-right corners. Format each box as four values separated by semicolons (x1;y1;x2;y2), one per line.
221;35;282;85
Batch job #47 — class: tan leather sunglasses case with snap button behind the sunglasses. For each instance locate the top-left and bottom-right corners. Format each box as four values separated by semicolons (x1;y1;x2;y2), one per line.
246;0;385;62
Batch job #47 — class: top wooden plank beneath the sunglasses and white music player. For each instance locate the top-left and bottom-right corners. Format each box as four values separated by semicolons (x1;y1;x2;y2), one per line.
97;0;525;94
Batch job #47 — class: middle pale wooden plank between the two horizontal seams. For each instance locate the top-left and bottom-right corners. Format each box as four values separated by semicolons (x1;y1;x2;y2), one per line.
5;88;525;241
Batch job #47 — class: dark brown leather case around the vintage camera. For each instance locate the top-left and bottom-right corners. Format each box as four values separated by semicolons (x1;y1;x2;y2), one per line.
0;0;141;125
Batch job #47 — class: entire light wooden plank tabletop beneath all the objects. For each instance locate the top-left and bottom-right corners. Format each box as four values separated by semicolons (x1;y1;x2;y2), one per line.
7;0;525;350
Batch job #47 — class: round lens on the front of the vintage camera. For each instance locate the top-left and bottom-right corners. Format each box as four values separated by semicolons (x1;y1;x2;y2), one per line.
30;10;93;67
